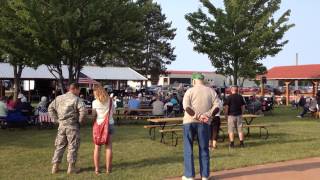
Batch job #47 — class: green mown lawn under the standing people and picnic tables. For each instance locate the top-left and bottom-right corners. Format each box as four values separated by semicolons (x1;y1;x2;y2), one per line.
0;107;320;180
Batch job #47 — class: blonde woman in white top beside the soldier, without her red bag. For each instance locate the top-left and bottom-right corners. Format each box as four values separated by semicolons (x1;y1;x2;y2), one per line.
92;85;114;174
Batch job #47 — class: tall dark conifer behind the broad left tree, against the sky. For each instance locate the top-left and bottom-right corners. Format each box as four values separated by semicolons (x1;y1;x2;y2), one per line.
111;0;176;81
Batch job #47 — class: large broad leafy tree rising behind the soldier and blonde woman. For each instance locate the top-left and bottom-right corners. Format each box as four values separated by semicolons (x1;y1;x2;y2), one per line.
21;0;141;89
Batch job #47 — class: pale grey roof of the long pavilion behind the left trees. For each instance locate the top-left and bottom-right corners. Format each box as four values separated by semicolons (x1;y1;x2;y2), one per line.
0;63;147;81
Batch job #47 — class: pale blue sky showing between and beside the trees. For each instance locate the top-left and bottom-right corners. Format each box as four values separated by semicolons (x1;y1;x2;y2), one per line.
156;0;320;71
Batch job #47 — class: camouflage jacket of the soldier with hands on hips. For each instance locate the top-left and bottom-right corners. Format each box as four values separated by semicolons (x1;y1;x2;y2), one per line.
48;92;86;128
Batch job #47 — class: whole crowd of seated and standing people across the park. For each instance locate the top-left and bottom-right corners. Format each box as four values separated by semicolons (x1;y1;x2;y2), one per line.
0;73;320;180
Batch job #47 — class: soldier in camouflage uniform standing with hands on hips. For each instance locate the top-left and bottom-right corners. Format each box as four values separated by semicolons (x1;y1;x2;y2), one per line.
48;83;86;174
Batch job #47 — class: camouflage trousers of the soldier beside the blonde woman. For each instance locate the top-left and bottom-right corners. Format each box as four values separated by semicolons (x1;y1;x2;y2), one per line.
52;127;80;164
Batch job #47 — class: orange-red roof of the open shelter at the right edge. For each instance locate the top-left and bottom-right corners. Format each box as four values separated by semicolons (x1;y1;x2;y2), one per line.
264;64;320;80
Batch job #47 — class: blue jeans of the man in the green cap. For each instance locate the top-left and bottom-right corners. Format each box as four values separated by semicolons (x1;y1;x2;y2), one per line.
183;123;210;178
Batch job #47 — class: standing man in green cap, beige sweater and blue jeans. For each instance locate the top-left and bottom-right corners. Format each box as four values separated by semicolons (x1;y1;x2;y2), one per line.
182;73;219;180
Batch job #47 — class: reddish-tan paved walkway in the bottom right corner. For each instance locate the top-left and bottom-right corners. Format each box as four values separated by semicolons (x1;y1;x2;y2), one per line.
168;158;320;180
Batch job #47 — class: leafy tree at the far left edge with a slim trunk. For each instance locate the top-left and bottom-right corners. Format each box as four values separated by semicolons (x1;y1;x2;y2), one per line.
0;0;39;99
